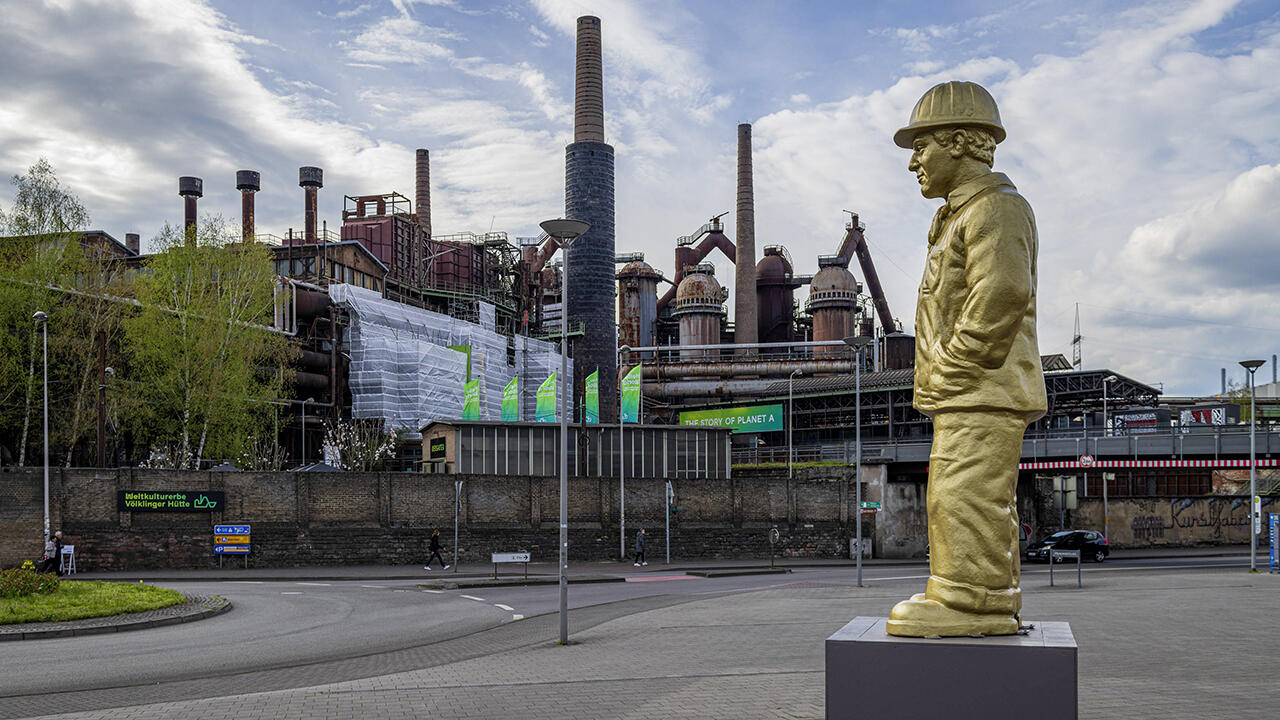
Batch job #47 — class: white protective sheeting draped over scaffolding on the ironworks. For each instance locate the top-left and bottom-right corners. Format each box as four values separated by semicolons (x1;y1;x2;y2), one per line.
329;284;573;432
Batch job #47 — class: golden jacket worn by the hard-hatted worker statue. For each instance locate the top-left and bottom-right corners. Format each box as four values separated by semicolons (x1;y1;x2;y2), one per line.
914;173;1046;423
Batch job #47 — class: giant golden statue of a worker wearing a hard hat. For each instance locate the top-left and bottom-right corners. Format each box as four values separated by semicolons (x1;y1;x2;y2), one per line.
886;82;1046;637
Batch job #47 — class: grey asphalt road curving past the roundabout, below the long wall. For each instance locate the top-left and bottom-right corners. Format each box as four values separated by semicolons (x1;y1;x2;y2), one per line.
0;548;1248;717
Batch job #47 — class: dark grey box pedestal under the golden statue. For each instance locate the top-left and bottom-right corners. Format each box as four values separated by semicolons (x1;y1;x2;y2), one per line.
827;618;1078;720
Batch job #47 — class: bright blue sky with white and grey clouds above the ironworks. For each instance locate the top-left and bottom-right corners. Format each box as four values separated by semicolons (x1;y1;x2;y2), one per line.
0;0;1280;393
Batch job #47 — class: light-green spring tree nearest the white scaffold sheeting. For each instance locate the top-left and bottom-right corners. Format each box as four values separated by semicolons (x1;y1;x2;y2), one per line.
124;217;289;468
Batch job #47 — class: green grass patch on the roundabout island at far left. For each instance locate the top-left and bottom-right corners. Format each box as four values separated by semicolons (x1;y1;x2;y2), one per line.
0;580;187;625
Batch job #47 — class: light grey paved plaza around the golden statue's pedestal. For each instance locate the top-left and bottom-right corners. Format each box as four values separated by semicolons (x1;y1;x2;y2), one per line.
7;565;1280;720
